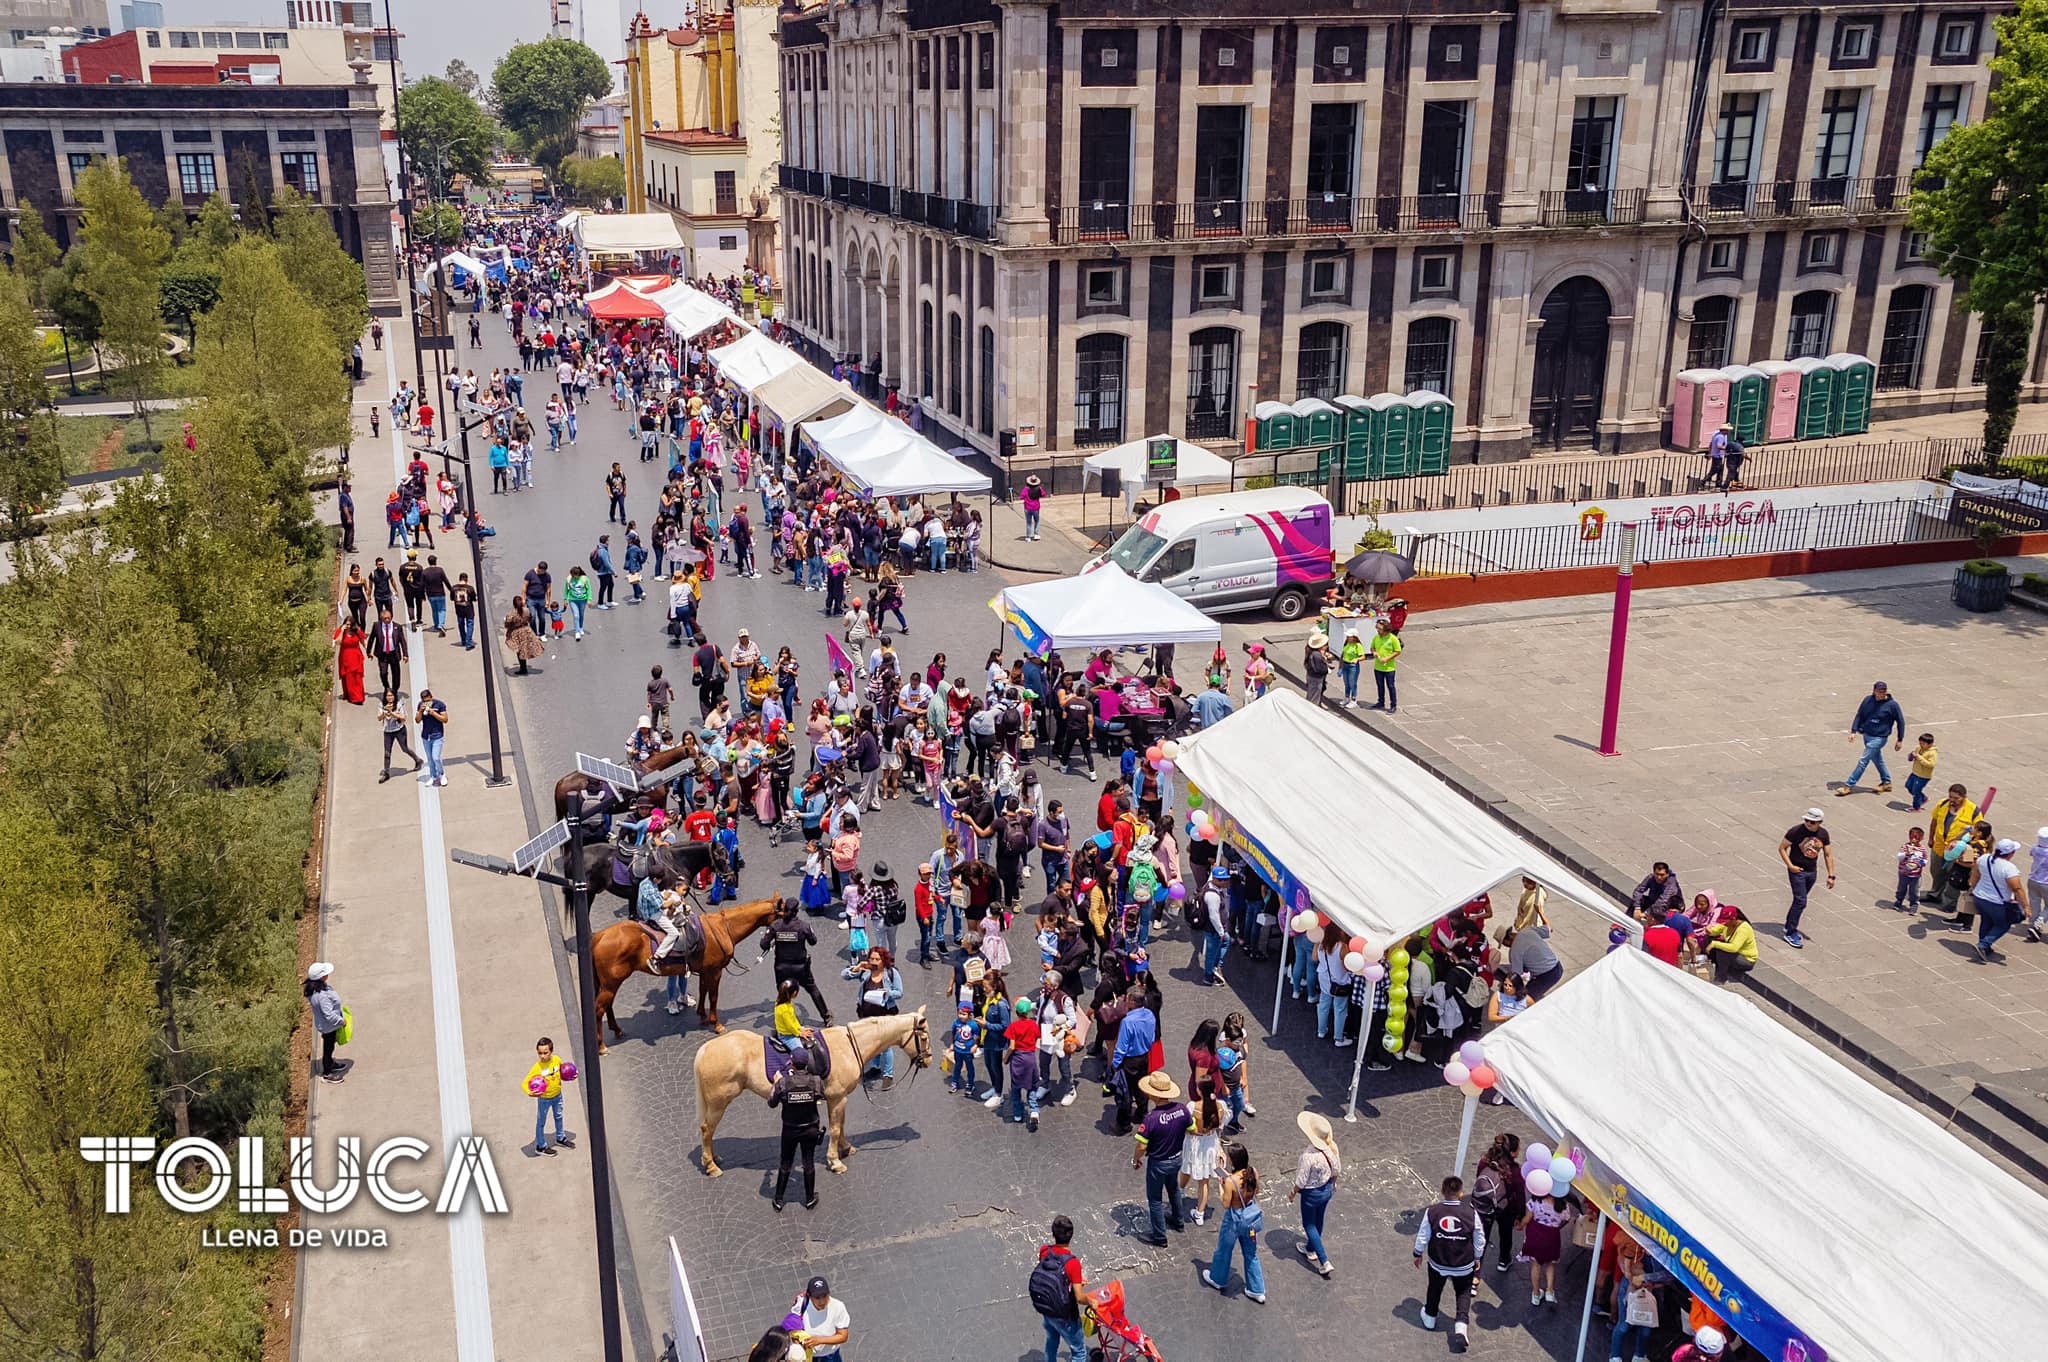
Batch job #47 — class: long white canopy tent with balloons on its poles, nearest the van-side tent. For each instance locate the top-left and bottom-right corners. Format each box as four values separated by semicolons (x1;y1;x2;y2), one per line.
1178;690;1640;1120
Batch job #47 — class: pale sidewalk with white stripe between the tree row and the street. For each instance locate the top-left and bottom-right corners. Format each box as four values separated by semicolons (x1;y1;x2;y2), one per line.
293;307;600;1362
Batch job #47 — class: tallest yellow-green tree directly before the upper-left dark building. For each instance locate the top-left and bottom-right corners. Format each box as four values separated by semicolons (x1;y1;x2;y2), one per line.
74;160;170;432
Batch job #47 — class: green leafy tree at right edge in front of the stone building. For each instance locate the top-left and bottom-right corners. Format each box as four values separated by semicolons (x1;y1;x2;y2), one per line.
1913;0;2048;459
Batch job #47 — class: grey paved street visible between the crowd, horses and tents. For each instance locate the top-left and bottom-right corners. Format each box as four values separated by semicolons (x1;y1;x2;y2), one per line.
432;311;1605;1362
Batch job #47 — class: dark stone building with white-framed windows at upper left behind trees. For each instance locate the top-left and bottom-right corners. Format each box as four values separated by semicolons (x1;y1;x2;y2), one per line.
0;80;399;313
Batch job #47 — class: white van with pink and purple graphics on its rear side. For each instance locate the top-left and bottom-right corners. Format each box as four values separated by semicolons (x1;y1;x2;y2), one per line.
1083;487;1335;621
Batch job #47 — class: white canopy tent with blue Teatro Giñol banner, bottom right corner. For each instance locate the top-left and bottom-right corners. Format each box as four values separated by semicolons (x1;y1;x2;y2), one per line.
1485;950;2048;1362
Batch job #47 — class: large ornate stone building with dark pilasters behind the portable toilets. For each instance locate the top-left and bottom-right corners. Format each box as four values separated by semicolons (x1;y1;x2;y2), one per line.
780;0;2042;463
